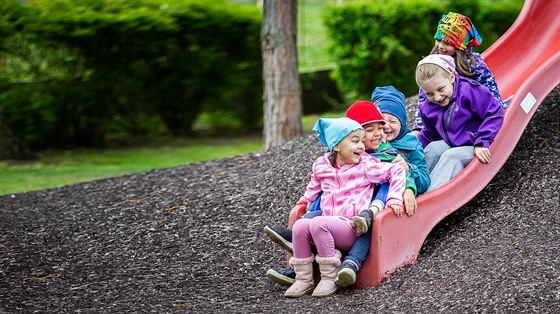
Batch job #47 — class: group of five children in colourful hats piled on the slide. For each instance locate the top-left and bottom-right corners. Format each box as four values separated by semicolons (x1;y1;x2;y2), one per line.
265;12;507;298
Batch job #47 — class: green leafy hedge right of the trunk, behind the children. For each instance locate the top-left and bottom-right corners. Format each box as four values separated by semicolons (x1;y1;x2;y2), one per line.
323;0;523;100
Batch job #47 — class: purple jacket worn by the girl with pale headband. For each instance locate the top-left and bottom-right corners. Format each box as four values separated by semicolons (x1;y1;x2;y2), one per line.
418;73;504;148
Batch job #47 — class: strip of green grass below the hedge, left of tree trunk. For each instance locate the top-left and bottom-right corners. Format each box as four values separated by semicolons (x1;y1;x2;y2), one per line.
0;135;262;195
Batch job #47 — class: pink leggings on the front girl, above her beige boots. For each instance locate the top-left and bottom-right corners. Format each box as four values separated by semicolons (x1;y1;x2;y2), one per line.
292;216;357;258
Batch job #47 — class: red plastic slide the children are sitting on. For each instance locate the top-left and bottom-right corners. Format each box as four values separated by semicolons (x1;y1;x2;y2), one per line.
288;0;560;288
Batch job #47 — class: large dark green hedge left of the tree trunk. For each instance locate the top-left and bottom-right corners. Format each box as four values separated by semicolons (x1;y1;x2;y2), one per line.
0;0;262;147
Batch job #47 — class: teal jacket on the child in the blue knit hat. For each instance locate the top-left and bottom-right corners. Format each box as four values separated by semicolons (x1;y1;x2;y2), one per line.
391;133;430;194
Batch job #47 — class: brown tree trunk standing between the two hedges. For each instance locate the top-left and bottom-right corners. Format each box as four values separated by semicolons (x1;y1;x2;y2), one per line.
261;0;302;149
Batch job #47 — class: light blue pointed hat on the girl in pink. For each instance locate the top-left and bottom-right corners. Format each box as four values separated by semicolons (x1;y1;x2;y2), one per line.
313;118;363;152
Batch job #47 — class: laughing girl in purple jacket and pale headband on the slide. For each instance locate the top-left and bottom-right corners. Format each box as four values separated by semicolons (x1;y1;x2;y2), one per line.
416;54;504;192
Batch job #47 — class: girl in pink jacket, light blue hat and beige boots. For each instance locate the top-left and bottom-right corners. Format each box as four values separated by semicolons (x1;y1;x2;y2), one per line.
284;118;406;298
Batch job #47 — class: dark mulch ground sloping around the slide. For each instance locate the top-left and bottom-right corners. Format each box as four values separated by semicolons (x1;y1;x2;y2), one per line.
0;87;560;313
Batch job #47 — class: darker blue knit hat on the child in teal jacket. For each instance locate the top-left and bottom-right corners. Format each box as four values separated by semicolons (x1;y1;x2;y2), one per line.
371;86;410;140
